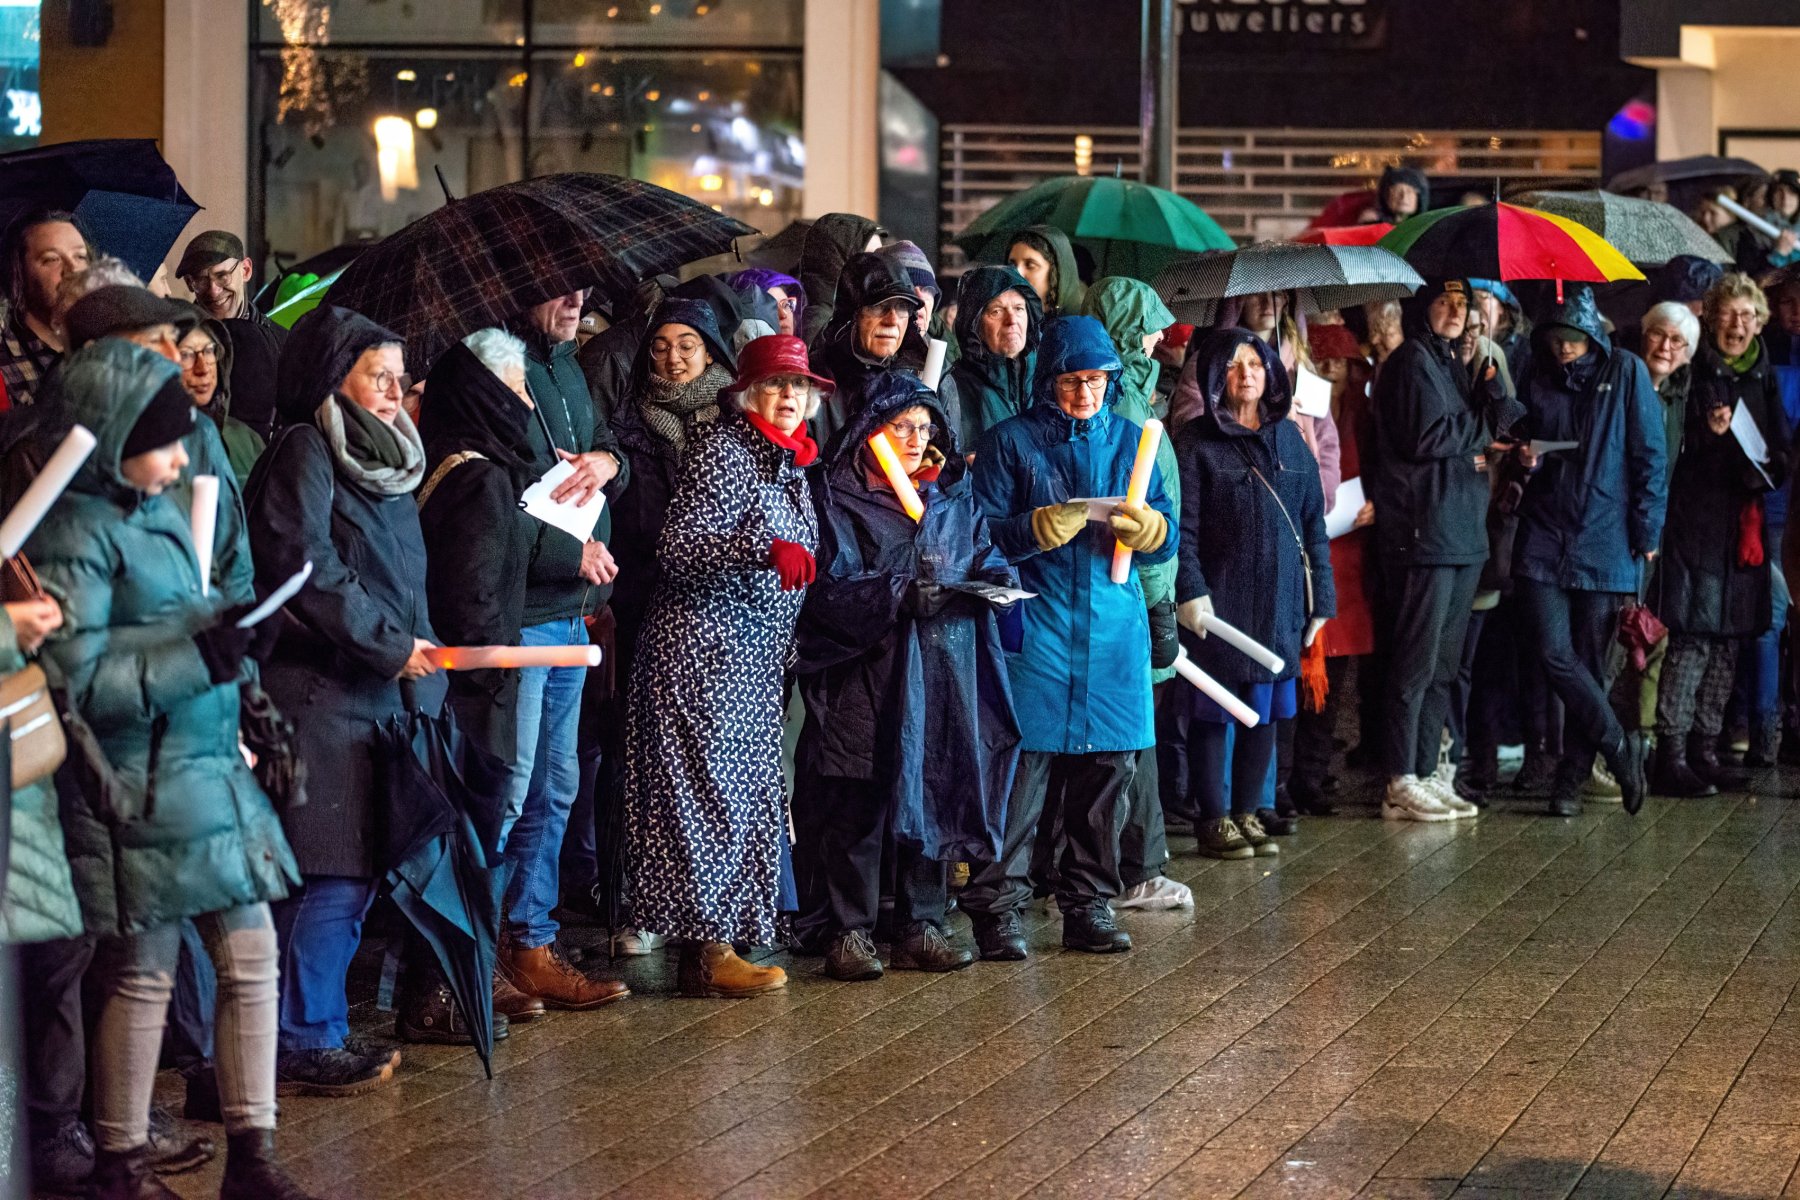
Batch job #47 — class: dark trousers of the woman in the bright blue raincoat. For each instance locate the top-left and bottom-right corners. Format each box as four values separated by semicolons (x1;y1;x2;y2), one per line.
958;750;1138;914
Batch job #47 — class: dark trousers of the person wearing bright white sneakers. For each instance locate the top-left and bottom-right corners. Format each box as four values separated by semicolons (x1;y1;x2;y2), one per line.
1384;565;1481;777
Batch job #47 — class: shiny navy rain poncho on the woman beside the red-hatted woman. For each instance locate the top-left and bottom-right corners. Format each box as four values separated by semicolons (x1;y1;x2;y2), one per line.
797;371;1019;862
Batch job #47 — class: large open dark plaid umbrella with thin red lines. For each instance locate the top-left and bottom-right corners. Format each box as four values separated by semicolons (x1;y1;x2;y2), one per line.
331;175;756;374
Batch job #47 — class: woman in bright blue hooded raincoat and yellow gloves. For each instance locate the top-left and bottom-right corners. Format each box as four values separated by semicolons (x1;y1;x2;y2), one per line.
961;317;1177;959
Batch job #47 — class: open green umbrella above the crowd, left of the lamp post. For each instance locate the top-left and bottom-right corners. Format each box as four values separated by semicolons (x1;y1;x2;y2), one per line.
950;175;1237;282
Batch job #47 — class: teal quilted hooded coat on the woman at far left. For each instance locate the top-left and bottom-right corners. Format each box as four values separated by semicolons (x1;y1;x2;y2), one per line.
25;338;299;936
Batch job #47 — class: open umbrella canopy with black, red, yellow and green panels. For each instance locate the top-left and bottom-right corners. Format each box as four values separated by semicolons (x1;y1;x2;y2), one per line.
1381;203;1643;282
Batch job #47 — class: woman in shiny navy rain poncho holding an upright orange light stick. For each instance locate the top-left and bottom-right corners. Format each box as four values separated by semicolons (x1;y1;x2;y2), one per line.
797;371;1019;979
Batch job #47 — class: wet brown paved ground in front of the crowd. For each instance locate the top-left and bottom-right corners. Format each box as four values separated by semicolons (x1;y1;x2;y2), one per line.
167;779;1800;1200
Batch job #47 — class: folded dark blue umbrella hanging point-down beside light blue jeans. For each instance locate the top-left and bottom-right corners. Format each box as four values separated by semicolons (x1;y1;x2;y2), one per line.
376;709;511;1078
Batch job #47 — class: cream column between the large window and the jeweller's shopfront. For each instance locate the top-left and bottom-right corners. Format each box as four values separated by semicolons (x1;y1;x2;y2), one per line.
803;0;882;218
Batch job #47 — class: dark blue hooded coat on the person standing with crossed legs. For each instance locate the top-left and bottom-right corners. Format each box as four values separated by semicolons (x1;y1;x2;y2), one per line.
1512;286;1669;594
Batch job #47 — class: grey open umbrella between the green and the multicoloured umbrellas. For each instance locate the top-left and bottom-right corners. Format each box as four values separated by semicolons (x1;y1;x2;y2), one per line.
1156;241;1426;326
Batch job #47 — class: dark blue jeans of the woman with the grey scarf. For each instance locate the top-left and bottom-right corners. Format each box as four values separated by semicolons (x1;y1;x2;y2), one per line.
270;874;376;1054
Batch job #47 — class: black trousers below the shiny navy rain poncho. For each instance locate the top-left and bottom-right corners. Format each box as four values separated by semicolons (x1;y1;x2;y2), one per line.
814;777;950;937
